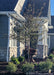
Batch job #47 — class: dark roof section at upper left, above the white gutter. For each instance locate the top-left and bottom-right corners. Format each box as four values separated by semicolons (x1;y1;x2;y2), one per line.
0;0;18;11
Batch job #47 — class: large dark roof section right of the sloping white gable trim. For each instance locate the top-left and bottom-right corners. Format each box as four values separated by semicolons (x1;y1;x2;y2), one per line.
23;0;50;17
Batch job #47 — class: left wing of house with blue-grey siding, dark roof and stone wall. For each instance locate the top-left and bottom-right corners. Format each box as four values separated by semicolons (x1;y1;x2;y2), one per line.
0;0;25;61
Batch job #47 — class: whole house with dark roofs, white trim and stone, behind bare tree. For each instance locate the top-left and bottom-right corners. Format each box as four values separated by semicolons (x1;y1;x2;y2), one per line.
0;0;54;62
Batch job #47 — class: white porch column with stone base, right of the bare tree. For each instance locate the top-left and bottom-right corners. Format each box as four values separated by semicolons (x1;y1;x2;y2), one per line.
37;23;48;59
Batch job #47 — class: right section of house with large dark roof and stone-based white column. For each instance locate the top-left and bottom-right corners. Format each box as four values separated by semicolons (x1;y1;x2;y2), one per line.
23;0;52;58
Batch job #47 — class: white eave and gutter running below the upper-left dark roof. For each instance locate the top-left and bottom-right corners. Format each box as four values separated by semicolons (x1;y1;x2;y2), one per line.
0;11;26;22
